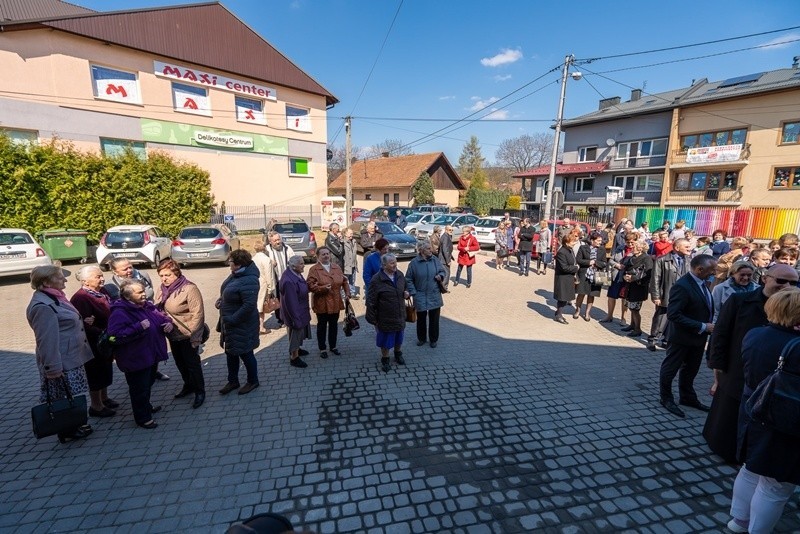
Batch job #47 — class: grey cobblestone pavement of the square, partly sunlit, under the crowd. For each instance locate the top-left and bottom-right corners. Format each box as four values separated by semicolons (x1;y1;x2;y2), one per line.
0;256;800;533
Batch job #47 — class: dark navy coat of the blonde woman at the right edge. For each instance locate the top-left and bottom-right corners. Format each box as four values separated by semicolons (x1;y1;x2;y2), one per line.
738;325;800;484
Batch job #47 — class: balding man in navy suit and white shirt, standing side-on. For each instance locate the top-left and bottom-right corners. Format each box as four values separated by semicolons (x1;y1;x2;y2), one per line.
659;254;717;417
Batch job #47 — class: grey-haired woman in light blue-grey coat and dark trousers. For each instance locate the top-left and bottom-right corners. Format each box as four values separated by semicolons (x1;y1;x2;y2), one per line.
406;242;447;348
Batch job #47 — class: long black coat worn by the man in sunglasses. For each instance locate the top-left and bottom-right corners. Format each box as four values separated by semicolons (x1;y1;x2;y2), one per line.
703;287;768;463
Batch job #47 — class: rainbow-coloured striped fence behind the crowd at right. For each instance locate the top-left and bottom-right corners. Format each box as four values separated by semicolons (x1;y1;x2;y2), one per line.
614;207;800;240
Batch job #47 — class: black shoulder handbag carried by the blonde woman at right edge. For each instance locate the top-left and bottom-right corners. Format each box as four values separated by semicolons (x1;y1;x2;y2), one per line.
744;337;800;437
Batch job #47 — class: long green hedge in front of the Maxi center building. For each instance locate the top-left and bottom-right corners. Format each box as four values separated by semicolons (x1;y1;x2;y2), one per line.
0;135;214;240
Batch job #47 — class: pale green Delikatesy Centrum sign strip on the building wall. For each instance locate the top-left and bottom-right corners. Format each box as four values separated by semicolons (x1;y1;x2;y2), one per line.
140;119;289;156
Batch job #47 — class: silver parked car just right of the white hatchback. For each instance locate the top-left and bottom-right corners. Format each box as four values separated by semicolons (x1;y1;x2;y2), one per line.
172;224;240;265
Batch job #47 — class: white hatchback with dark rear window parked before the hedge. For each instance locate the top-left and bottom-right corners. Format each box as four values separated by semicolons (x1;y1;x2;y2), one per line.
96;224;172;271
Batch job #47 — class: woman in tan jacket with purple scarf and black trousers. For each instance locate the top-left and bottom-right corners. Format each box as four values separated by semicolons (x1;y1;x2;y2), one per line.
156;258;206;408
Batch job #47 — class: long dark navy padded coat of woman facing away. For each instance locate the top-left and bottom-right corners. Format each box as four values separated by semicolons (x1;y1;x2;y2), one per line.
219;263;261;354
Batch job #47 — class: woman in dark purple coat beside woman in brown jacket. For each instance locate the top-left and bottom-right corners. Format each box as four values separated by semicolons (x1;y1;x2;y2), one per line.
280;256;311;369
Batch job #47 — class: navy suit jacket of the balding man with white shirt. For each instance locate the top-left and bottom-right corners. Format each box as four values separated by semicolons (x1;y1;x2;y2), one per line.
664;272;714;347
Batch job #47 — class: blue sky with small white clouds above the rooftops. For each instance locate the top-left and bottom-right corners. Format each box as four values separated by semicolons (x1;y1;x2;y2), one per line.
73;0;800;164
